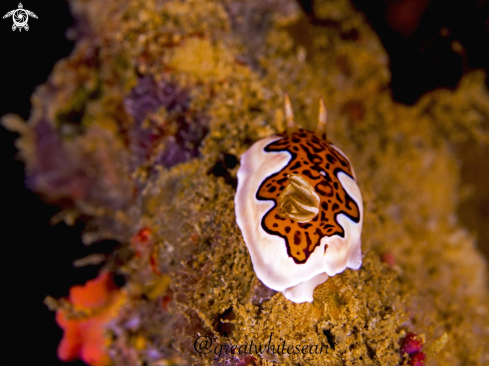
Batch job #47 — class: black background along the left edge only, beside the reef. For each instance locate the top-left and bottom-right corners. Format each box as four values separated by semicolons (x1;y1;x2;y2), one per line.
0;0;91;366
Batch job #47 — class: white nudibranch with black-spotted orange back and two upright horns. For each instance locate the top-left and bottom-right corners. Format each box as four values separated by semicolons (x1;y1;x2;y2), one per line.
234;95;363;303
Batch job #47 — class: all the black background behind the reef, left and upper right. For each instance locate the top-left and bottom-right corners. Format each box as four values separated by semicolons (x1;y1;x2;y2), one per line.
0;0;489;365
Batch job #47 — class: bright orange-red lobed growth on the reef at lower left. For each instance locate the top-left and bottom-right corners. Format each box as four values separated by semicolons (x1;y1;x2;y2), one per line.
56;272;124;366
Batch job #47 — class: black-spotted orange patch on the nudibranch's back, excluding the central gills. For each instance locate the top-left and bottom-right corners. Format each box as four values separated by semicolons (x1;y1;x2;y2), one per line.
256;129;360;264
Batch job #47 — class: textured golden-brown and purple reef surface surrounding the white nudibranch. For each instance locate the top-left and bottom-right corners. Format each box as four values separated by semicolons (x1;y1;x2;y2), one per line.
3;0;489;366
